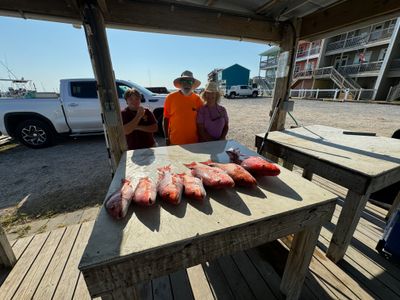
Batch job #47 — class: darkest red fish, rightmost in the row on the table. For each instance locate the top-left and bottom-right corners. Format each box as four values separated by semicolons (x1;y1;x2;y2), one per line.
226;149;281;176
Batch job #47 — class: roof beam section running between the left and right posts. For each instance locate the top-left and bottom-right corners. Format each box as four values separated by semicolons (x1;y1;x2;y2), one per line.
105;1;281;42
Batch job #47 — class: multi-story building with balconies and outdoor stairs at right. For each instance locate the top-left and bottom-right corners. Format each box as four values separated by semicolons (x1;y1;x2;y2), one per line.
260;18;400;100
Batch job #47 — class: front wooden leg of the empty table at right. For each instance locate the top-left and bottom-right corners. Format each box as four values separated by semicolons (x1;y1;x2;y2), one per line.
326;190;369;263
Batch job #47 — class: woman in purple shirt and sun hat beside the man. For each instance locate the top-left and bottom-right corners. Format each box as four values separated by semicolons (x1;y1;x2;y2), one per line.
197;82;229;142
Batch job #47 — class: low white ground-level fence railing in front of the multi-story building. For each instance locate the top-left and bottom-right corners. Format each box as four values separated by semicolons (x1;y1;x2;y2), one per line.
290;89;376;101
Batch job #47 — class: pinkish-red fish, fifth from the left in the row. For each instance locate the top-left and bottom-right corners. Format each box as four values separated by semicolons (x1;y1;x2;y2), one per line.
184;162;235;189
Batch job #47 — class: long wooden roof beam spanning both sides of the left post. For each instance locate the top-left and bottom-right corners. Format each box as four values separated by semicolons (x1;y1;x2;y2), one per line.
0;0;281;42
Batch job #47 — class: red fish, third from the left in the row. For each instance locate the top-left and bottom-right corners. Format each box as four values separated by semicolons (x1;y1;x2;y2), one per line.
157;166;183;205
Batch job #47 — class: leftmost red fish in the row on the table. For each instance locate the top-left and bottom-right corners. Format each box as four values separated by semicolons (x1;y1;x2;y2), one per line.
105;179;134;220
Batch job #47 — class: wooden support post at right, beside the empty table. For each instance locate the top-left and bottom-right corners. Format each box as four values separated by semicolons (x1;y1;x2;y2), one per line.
270;21;300;131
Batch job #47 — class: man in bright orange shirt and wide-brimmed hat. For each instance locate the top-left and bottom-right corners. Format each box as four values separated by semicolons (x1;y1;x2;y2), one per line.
163;71;203;146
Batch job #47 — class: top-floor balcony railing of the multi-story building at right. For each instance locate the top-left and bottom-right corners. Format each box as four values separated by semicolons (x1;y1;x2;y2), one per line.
326;27;394;52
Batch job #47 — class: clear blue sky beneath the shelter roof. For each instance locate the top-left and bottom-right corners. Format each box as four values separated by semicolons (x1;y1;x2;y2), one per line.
0;17;268;91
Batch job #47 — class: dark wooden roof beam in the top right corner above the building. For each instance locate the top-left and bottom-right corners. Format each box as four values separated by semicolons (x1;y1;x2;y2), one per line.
300;0;400;40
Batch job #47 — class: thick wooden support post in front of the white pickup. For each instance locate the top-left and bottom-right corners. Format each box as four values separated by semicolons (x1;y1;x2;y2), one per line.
81;0;127;174
